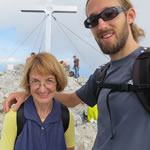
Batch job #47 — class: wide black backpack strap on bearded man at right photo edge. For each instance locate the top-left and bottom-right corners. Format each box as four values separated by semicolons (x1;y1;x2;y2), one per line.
132;48;150;112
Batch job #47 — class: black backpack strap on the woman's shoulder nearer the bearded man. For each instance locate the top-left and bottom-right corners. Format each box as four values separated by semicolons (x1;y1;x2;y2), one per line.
61;104;70;133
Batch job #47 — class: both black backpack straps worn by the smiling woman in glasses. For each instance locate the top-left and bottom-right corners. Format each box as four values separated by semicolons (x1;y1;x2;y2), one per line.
16;103;70;139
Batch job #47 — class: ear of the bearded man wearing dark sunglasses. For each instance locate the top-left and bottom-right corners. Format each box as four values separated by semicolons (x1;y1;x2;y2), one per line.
127;8;136;24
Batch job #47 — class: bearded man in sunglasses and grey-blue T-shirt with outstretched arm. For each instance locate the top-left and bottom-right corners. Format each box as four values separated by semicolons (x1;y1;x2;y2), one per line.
2;0;150;150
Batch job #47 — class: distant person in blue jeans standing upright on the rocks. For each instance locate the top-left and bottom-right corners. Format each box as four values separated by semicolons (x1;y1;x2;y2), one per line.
73;56;80;78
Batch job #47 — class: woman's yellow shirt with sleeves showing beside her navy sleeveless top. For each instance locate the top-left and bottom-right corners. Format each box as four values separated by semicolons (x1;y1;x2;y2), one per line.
0;109;75;150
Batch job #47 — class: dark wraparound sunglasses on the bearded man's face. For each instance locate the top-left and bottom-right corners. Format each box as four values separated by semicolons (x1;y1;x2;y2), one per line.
84;6;126;28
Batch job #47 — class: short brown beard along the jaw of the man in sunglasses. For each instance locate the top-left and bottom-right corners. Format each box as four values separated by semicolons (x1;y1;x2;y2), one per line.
96;24;129;55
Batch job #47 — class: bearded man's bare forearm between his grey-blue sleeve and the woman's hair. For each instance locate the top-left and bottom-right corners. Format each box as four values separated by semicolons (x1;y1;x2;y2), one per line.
55;92;82;107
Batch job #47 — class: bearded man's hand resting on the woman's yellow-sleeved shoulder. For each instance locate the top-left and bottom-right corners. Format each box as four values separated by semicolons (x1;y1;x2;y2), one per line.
3;92;29;112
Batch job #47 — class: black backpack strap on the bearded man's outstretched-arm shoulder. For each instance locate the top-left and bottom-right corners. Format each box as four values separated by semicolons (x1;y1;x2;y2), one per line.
96;62;110;100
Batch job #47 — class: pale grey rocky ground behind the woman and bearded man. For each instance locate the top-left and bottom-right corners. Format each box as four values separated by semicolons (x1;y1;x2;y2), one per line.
0;64;97;150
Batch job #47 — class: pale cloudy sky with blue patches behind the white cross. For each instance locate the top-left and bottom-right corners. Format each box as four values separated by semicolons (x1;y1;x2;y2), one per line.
0;0;150;77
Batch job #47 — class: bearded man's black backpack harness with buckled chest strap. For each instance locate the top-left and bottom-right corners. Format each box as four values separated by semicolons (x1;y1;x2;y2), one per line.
96;48;150;112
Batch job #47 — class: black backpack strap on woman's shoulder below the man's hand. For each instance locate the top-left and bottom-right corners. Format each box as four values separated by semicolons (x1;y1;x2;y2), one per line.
17;103;26;137
